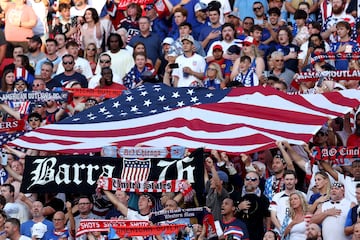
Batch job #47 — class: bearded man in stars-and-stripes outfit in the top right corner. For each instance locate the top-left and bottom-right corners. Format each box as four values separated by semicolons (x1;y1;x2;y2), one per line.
321;0;356;43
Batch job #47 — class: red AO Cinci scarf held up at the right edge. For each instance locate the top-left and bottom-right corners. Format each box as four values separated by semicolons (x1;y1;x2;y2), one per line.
313;146;360;165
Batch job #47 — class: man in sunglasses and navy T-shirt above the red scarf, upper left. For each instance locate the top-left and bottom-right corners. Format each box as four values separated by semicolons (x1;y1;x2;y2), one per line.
51;54;88;89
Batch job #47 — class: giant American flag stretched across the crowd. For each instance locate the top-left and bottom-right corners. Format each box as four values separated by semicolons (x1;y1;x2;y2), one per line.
8;84;360;153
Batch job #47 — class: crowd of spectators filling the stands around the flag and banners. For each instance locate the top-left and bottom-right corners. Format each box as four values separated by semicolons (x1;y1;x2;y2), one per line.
0;0;360;240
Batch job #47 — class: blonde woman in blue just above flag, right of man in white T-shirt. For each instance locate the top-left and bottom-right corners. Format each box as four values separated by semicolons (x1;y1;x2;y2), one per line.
204;62;225;90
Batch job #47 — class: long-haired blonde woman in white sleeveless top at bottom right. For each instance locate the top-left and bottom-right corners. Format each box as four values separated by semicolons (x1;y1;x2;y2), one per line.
283;191;308;240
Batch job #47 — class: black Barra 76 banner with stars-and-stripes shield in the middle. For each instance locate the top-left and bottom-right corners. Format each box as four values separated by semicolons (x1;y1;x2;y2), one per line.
21;149;204;194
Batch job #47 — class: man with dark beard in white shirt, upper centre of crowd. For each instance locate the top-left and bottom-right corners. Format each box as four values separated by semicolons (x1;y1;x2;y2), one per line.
206;23;236;62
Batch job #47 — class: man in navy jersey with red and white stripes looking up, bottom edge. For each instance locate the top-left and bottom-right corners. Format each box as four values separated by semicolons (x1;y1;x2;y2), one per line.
220;197;252;240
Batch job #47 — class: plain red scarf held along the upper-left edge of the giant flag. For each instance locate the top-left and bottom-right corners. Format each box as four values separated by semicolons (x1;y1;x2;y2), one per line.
64;88;123;98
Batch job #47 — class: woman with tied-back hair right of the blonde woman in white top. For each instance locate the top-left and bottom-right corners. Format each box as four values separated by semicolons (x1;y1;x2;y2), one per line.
309;171;330;213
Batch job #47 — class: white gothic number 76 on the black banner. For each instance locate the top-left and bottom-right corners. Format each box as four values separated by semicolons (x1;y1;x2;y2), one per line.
157;157;195;183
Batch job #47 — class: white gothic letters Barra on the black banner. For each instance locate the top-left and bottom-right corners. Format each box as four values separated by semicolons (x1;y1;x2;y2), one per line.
27;157;115;190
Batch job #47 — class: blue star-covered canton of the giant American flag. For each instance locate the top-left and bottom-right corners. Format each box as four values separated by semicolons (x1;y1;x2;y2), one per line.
62;84;230;124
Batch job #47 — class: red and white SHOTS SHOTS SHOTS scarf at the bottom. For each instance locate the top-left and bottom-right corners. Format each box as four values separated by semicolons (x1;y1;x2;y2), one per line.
76;219;149;237
